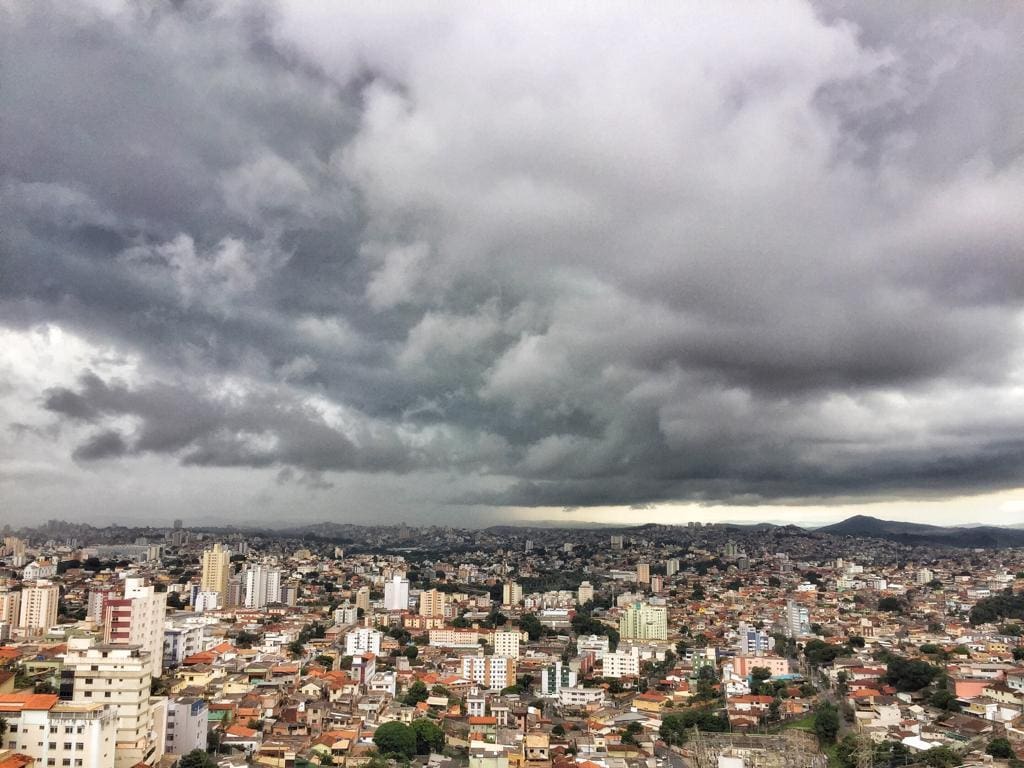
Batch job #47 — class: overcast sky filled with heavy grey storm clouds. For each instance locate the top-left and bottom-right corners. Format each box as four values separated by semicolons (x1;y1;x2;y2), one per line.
0;0;1024;525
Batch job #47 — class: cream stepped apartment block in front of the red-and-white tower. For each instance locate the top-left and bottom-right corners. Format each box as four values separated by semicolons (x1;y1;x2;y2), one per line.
60;638;164;768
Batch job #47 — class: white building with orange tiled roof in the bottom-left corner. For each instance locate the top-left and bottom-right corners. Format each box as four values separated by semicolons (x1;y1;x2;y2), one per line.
0;693;116;768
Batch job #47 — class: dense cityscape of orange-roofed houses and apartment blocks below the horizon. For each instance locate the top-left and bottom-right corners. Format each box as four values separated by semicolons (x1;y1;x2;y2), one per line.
0;521;1024;768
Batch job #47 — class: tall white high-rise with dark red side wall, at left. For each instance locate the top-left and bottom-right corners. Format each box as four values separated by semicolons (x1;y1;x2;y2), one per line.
103;577;167;678
